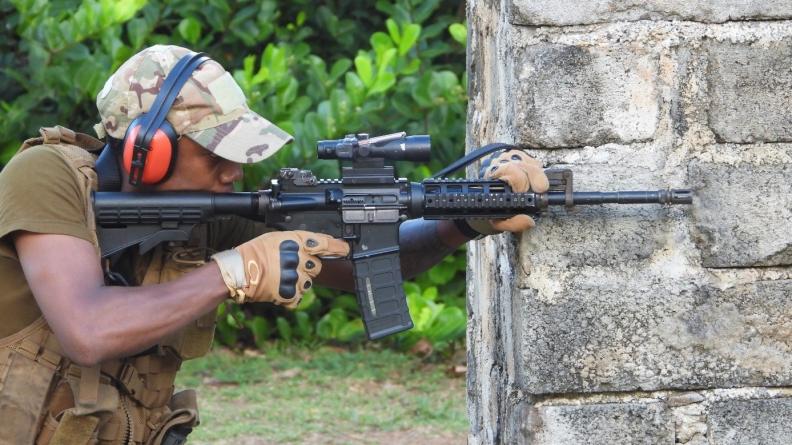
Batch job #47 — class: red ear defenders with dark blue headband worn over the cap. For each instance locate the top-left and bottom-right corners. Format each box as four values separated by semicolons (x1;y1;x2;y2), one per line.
122;53;210;185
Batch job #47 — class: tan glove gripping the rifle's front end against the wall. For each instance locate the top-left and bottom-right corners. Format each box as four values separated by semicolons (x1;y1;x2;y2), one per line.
467;150;550;235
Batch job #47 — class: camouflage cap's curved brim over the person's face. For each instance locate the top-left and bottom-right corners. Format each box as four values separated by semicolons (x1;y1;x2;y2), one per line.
185;110;294;164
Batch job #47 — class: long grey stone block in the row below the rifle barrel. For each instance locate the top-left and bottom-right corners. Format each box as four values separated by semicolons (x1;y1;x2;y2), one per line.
512;280;792;394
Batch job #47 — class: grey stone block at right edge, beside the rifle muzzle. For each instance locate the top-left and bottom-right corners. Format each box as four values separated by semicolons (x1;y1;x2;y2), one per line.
688;160;792;267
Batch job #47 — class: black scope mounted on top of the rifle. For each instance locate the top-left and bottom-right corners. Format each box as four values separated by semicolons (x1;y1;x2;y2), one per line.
316;132;432;162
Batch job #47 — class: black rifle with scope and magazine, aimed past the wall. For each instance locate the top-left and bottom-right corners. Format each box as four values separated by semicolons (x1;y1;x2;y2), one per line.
94;133;692;340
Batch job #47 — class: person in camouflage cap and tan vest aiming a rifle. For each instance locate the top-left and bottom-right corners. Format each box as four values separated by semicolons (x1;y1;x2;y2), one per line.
0;46;547;444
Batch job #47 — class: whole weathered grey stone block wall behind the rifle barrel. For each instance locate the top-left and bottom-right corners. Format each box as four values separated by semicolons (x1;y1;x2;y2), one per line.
468;0;792;445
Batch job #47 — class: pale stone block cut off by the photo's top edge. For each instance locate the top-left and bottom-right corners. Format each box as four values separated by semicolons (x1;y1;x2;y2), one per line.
512;0;792;26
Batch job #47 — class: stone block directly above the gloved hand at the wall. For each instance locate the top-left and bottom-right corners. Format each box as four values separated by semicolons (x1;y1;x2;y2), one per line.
512;43;659;147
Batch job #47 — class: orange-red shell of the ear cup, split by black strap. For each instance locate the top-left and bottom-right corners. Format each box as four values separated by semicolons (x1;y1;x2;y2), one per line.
123;120;178;185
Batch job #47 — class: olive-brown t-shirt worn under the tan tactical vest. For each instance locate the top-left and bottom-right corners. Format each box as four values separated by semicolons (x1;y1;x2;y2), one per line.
0;145;268;338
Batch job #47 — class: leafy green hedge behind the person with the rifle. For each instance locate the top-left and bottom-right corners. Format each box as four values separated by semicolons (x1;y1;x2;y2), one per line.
0;0;467;350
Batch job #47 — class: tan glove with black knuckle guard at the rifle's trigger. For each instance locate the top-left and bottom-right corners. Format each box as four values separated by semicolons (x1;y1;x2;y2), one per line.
212;230;349;309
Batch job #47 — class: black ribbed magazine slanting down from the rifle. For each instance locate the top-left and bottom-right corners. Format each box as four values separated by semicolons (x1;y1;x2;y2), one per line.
352;246;413;340
